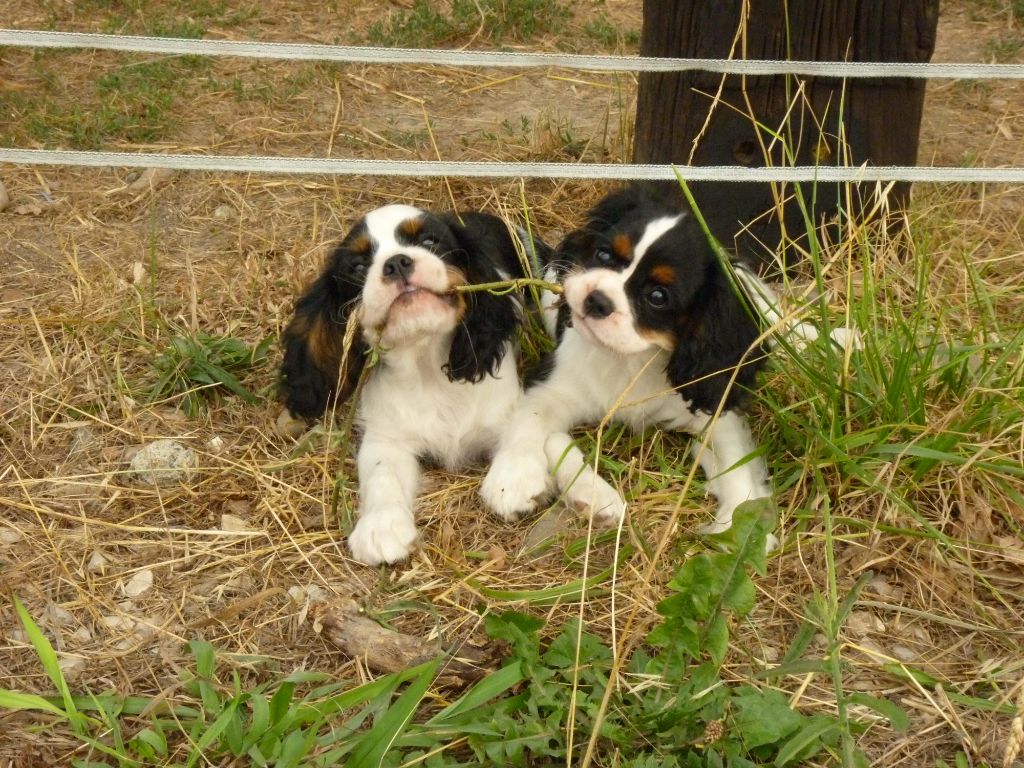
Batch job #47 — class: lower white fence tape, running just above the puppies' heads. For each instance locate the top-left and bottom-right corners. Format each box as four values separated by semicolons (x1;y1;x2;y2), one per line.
0;148;1024;183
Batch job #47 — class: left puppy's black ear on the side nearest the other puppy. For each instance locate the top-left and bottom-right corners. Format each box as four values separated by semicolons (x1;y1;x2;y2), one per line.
444;215;523;382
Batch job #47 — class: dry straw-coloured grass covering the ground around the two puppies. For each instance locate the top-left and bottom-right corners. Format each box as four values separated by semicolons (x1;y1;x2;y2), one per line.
0;0;1024;768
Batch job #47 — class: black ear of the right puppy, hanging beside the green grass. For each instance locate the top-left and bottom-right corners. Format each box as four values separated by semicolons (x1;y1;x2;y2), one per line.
666;265;767;413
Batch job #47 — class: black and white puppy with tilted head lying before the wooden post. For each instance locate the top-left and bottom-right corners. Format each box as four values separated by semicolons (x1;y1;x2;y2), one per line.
480;187;843;532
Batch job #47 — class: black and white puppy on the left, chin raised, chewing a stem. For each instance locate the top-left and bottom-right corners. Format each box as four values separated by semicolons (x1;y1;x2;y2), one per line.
282;205;536;565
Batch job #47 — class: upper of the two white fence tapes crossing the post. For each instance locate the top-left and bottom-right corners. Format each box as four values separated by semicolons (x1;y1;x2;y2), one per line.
0;30;1024;80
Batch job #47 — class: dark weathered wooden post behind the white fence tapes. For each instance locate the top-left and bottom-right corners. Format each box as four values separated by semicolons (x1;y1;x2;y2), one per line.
634;0;938;270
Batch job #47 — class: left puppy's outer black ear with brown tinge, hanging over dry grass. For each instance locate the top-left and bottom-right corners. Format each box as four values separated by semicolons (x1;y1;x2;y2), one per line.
281;246;367;419
